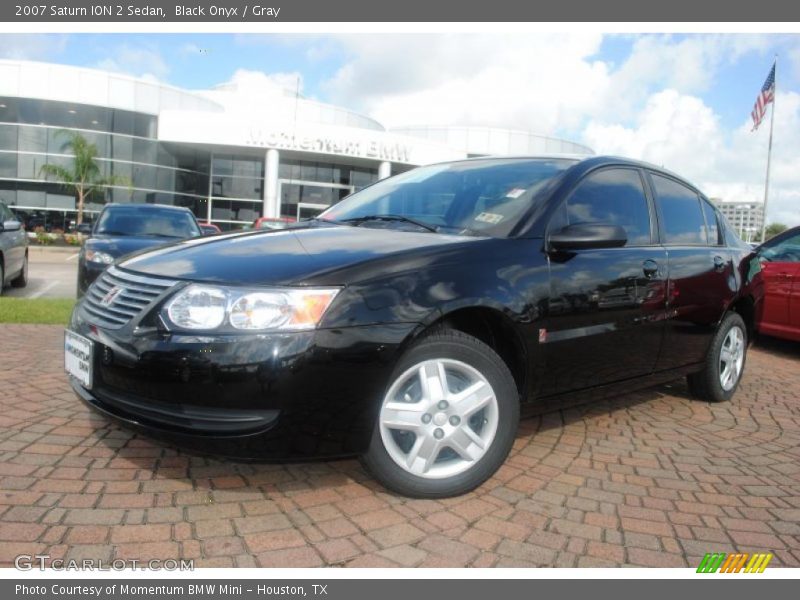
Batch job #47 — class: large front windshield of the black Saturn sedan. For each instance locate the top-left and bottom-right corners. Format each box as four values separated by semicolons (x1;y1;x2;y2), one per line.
320;159;575;237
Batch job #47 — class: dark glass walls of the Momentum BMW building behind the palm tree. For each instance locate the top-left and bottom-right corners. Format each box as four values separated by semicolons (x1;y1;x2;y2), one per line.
0;97;378;230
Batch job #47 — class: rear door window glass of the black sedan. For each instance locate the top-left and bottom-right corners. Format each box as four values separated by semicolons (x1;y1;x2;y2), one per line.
652;174;708;245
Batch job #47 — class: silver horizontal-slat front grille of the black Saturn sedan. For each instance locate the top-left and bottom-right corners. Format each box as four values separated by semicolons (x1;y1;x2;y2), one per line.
83;267;176;329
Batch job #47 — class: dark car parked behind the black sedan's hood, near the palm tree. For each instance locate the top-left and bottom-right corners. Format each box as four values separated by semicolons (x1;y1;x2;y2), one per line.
78;204;202;298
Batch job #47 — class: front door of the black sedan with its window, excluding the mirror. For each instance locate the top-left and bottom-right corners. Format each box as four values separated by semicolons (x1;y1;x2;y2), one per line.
539;168;667;395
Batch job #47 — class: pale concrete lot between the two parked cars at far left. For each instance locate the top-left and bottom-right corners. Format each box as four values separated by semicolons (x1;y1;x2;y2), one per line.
3;246;78;298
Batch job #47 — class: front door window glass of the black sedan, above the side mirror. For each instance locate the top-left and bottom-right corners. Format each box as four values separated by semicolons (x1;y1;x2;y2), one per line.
550;169;651;246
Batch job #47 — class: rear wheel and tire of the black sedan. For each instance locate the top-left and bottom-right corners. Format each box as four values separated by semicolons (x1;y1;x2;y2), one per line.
686;312;747;402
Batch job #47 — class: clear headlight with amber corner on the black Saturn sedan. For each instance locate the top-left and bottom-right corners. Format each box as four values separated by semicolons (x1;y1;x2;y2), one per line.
166;284;339;331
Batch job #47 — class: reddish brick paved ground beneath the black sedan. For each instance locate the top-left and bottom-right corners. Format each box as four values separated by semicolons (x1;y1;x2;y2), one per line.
0;325;800;567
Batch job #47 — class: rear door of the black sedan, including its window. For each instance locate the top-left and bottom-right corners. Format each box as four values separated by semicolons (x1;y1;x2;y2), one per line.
650;172;736;370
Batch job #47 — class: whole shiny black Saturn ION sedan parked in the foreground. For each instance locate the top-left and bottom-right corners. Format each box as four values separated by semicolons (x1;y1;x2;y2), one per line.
65;157;762;498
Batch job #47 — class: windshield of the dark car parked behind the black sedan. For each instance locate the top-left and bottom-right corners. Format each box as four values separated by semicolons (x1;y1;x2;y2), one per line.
95;205;201;238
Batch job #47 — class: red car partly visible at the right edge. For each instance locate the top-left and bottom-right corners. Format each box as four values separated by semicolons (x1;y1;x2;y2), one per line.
757;227;800;342
